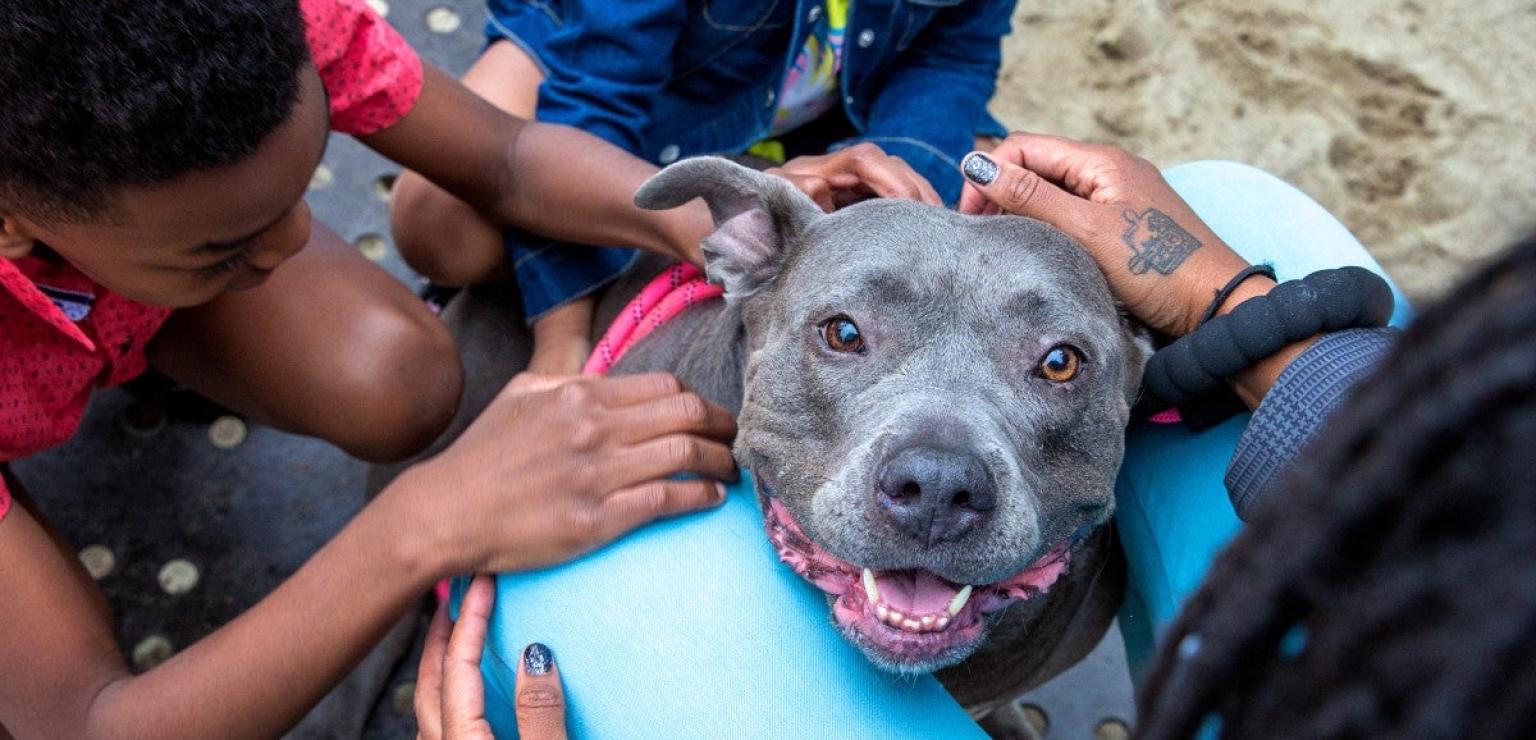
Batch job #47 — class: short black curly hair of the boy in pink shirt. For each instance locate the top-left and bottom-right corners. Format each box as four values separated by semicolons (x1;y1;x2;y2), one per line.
0;0;309;220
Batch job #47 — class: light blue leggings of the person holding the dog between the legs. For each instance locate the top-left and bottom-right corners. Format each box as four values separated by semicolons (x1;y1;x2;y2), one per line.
455;161;1407;738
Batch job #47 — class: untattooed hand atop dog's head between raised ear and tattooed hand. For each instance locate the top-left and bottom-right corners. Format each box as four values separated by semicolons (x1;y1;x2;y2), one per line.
765;141;943;213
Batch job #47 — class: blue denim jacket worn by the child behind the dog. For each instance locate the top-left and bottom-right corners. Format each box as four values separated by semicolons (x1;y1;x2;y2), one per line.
490;0;1015;203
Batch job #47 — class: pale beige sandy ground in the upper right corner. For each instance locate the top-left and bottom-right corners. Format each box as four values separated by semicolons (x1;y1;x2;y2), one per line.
992;0;1536;296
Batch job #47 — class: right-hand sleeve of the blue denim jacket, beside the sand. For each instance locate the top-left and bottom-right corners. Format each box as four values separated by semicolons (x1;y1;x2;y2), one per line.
841;0;1017;203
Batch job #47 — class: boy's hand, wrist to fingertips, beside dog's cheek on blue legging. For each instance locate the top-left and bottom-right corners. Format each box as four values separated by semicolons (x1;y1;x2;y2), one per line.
390;373;737;573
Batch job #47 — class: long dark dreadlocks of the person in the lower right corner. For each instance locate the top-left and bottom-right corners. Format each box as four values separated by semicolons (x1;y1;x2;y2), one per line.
1138;236;1536;740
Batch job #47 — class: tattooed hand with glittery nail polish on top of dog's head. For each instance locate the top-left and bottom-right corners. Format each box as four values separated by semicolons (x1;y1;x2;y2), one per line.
960;134;1273;336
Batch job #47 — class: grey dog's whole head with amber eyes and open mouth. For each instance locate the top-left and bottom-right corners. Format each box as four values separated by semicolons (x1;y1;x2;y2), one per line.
636;158;1146;671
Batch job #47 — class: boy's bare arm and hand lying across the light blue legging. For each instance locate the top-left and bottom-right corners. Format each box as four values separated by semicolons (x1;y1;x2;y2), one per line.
0;375;734;738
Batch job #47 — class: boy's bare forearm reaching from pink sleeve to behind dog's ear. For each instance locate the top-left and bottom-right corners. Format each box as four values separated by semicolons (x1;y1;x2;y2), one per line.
361;64;713;261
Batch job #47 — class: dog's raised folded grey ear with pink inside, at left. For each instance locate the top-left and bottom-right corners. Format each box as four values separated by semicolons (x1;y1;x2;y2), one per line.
634;157;822;302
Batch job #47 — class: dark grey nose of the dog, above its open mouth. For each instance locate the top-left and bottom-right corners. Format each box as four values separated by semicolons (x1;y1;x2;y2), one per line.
876;445;997;545
